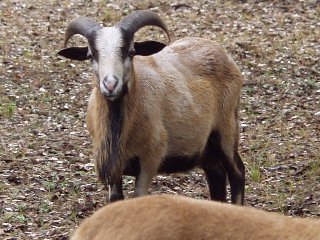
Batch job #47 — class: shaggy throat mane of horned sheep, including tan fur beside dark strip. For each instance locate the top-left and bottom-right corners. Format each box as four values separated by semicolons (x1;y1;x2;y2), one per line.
96;74;136;185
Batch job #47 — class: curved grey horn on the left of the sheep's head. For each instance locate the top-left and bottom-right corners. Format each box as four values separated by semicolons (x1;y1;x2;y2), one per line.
64;17;101;47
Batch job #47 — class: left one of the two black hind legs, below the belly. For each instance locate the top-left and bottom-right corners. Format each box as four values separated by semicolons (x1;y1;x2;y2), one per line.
204;164;227;202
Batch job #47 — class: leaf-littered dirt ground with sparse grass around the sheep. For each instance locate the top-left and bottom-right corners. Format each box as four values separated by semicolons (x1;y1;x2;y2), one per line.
0;0;320;240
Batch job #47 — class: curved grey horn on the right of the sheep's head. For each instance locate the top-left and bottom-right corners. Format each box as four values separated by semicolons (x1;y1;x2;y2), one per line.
117;10;170;42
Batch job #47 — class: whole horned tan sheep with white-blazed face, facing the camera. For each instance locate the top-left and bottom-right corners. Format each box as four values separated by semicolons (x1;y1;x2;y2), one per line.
58;10;245;204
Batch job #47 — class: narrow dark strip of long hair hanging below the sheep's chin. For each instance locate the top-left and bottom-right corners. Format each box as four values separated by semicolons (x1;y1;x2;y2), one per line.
96;101;124;186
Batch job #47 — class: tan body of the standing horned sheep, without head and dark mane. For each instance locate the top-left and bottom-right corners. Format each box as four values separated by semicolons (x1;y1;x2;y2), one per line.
87;38;244;203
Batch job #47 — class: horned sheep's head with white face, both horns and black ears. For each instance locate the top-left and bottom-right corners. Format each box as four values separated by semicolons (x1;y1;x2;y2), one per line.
58;10;170;101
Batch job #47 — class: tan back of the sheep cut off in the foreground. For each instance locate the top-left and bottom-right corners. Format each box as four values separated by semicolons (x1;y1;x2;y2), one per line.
70;195;320;240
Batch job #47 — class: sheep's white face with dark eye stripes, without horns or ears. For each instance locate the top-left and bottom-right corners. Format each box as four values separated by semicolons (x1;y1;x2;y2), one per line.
88;27;135;101
